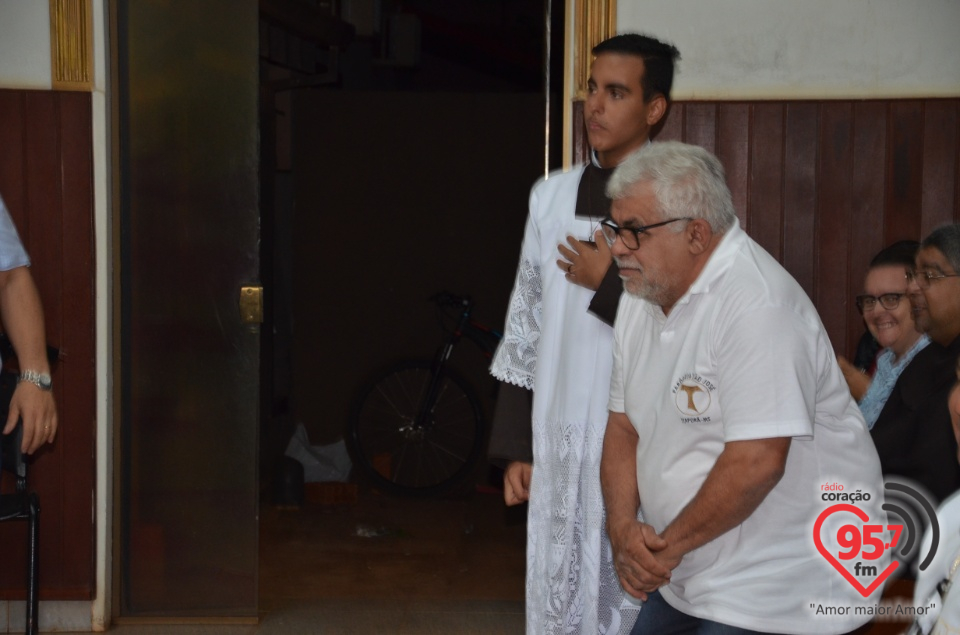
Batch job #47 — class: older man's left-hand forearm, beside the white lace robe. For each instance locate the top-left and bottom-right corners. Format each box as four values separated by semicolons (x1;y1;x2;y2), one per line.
600;412;640;532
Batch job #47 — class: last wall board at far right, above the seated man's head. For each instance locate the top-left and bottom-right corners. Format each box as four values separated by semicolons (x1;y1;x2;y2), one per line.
920;100;960;237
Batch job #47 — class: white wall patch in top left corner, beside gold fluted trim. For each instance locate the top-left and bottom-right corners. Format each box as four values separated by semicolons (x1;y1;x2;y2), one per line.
0;0;53;90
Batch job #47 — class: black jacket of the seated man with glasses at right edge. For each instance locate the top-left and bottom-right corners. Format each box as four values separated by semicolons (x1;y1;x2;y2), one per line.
870;338;960;504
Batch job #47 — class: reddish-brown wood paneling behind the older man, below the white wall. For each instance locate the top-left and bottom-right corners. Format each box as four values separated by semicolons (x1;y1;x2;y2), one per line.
577;99;960;355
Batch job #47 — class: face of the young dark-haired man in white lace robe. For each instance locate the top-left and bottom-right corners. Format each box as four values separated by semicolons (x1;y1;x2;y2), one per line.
583;53;667;168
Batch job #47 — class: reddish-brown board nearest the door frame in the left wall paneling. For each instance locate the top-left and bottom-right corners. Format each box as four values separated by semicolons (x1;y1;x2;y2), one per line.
58;92;96;598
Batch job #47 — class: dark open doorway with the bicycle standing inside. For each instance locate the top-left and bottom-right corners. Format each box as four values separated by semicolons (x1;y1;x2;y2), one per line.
260;0;564;611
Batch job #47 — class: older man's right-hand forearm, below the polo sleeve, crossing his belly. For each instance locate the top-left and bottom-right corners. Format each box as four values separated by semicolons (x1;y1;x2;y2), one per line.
661;438;790;559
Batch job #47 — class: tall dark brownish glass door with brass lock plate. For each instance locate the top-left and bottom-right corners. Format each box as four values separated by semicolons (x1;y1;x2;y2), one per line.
114;0;260;617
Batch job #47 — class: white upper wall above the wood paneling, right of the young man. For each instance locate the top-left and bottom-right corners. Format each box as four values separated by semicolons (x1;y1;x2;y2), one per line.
617;0;960;99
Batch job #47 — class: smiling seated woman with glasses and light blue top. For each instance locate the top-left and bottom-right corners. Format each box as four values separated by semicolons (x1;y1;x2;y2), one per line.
840;240;930;429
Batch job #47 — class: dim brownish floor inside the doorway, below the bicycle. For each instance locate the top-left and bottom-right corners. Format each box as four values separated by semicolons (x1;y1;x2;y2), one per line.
260;486;526;613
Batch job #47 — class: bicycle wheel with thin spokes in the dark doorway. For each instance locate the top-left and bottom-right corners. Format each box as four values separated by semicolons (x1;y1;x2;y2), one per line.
346;361;483;496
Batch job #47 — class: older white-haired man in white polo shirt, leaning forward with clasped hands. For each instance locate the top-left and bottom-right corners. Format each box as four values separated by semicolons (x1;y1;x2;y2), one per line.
601;143;889;634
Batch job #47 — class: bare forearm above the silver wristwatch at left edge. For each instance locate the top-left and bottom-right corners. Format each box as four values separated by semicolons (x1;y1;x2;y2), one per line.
0;267;50;373
